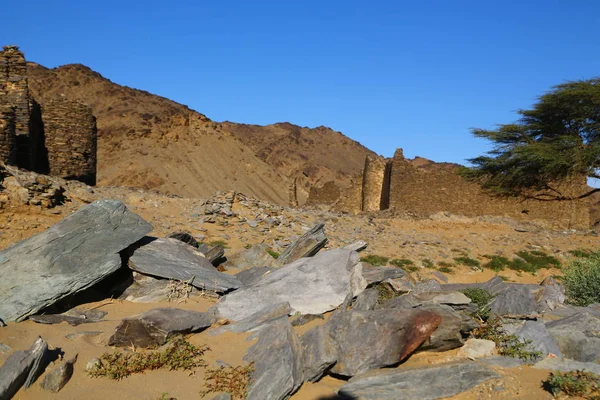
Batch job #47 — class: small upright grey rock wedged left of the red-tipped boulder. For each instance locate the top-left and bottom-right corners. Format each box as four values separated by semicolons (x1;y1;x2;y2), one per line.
300;325;337;382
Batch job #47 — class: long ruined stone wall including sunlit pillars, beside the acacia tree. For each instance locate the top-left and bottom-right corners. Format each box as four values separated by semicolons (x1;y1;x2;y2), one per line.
308;149;590;229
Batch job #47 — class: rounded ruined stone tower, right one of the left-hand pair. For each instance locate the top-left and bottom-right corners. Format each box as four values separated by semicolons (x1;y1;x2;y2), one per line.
42;97;97;185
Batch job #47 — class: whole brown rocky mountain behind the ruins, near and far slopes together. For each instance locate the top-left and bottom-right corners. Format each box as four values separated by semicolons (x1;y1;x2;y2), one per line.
28;63;373;204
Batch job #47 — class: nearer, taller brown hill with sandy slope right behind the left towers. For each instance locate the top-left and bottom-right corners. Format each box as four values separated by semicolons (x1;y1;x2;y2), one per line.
28;63;288;204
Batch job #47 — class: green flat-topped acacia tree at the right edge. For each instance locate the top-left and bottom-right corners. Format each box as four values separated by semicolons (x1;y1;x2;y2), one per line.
462;78;600;200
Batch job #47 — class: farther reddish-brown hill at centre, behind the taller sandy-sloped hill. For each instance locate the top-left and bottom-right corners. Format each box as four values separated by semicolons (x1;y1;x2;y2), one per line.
221;122;375;199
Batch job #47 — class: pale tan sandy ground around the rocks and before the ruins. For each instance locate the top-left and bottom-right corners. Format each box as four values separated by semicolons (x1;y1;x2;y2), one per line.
0;188;599;400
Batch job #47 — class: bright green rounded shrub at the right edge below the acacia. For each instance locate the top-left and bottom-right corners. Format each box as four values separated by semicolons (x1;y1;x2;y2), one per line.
562;256;600;307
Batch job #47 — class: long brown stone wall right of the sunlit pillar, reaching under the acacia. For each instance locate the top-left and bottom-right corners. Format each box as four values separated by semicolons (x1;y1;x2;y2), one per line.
390;150;590;229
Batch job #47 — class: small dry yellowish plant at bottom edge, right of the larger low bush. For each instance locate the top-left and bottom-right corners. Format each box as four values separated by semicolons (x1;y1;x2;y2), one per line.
200;364;254;400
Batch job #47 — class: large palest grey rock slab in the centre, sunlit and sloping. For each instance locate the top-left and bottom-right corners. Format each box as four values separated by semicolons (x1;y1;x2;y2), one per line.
216;249;358;321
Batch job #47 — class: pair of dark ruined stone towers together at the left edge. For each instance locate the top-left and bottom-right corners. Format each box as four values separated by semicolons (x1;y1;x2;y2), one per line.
0;46;97;185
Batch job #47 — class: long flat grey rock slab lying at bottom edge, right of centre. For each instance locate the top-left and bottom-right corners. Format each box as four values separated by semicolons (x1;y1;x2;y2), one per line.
338;362;500;400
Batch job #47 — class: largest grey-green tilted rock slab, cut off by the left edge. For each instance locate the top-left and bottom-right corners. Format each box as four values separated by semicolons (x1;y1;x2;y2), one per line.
0;200;152;322
